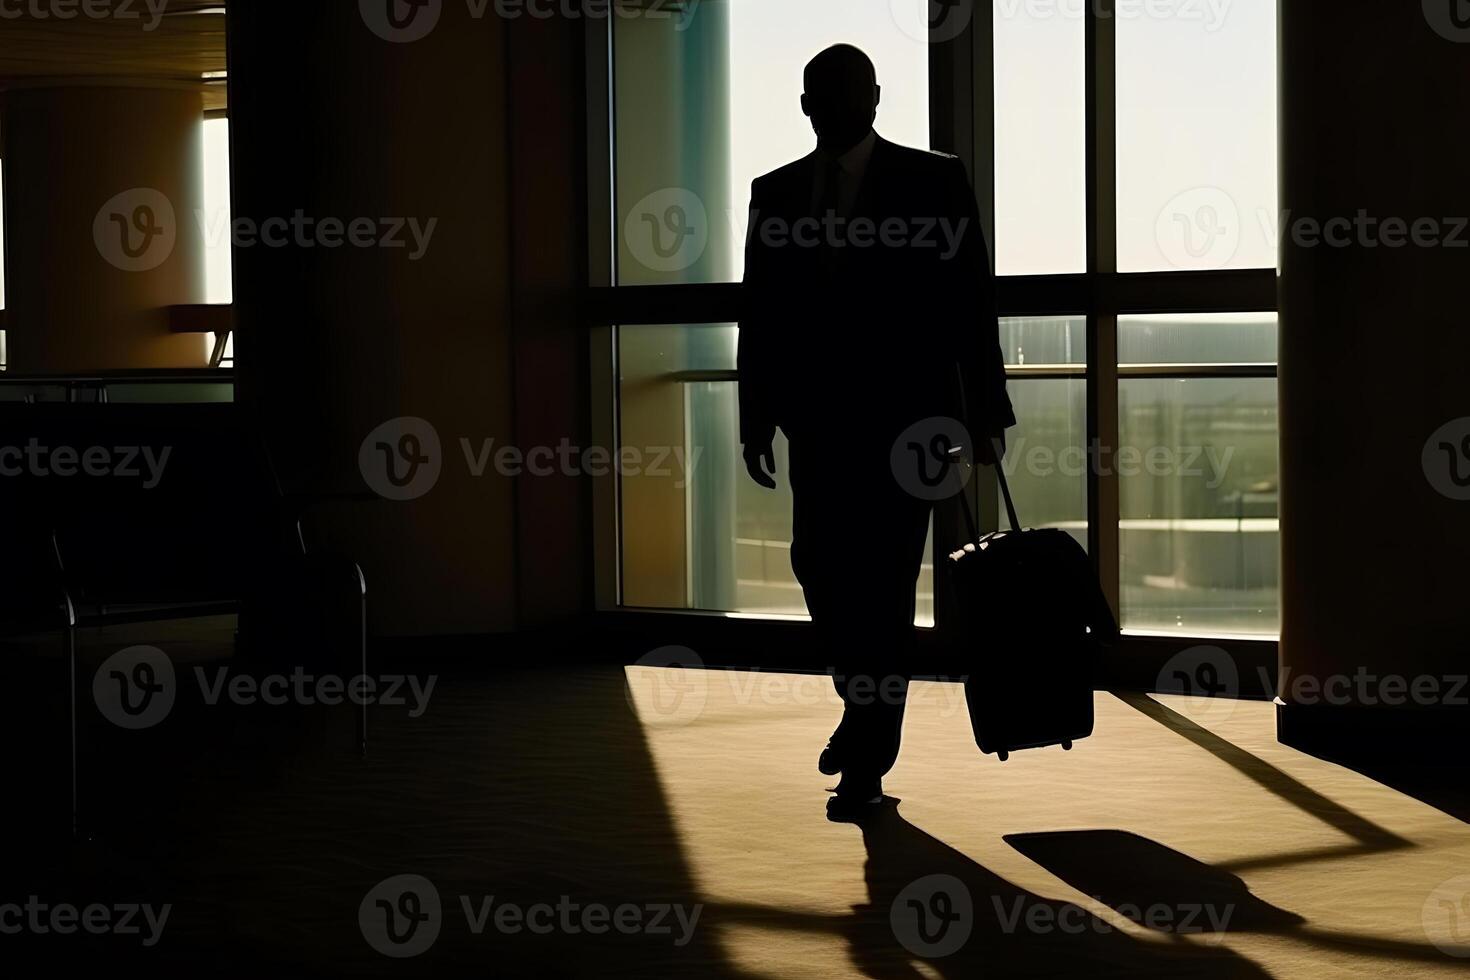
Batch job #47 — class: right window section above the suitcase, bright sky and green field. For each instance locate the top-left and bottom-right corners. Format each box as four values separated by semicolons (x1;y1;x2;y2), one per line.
978;0;1280;636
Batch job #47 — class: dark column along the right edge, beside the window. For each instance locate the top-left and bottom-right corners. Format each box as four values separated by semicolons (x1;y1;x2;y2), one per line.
1280;0;1470;760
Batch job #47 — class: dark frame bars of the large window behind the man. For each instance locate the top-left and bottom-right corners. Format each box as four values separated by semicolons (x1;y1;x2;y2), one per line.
584;0;1277;664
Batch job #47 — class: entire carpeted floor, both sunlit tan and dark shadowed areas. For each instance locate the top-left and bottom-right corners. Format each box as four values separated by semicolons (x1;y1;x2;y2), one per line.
0;620;1470;979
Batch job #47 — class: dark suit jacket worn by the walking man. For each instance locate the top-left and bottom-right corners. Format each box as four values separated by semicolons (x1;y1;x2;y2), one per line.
738;138;1016;451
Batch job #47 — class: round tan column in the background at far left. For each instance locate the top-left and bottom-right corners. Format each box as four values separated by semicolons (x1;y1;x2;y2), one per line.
0;82;209;373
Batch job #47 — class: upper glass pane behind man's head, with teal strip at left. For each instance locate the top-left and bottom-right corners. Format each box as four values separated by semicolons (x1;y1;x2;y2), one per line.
613;0;929;285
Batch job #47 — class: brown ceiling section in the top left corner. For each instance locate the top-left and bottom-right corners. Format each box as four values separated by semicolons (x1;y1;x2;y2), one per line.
0;0;228;110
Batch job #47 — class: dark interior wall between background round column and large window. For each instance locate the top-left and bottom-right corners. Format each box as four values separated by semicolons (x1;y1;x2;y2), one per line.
229;0;585;635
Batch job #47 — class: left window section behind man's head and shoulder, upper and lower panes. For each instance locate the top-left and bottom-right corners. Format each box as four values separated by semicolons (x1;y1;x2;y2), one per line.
612;0;933;624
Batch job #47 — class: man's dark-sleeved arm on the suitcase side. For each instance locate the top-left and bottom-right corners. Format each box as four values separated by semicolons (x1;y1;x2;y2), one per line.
947;159;1016;461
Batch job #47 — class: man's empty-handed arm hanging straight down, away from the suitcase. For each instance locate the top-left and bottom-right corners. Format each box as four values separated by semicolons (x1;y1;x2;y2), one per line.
735;181;776;489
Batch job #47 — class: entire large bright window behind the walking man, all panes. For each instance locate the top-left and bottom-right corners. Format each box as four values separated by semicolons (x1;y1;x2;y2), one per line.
594;0;1279;636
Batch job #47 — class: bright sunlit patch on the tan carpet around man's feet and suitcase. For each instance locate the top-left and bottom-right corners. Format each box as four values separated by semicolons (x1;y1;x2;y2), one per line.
628;667;1470;977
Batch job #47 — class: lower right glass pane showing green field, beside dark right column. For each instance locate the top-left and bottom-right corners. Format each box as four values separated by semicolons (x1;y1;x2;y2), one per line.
1113;378;1280;635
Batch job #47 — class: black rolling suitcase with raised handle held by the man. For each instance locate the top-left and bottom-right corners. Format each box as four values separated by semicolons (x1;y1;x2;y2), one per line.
945;447;1117;763
